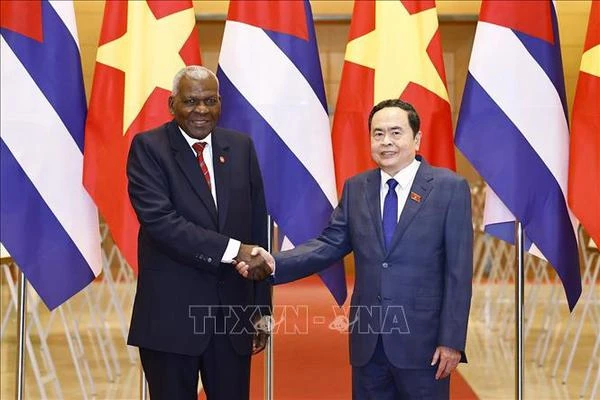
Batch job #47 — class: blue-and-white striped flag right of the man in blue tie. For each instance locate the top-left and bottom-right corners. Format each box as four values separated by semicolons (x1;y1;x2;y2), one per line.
455;0;581;310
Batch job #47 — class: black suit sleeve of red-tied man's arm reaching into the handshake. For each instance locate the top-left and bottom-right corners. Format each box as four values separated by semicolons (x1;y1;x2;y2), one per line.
127;135;229;273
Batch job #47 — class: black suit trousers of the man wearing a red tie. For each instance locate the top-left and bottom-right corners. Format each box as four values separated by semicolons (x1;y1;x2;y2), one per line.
140;312;250;400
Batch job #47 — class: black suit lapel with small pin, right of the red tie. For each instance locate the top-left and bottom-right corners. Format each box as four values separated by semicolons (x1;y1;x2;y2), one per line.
212;128;231;231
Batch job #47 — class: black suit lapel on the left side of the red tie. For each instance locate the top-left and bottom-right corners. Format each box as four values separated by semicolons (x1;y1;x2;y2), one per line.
168;121;217;225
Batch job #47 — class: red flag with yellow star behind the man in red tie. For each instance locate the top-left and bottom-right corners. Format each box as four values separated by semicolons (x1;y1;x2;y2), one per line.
84;0;200;270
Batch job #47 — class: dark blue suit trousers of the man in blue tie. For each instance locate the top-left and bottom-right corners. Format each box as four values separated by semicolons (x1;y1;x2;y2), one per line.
352;335;450;400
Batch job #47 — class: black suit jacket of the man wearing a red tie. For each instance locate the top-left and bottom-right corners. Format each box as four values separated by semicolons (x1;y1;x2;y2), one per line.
127;121;271;355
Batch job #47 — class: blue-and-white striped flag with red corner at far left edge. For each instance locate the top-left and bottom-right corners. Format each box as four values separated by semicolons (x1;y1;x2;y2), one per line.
0;1;102;309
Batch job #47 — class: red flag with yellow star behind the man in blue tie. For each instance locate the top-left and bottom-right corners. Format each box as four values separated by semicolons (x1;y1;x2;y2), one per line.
332;0;455;193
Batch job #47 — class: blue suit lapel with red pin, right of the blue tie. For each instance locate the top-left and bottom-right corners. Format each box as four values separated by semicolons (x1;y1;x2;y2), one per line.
390;159;433;249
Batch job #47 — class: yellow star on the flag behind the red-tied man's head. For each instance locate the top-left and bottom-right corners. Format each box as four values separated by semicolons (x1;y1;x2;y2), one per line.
96;1;195;134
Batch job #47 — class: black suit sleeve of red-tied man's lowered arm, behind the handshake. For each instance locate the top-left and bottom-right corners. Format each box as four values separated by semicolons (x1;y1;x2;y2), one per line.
249;142;272;315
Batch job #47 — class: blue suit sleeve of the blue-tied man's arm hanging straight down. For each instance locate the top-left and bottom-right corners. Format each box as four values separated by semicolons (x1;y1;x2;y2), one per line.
438;179;473;361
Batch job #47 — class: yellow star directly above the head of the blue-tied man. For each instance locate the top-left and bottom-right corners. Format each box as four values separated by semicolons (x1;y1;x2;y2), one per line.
345;1;448;103
